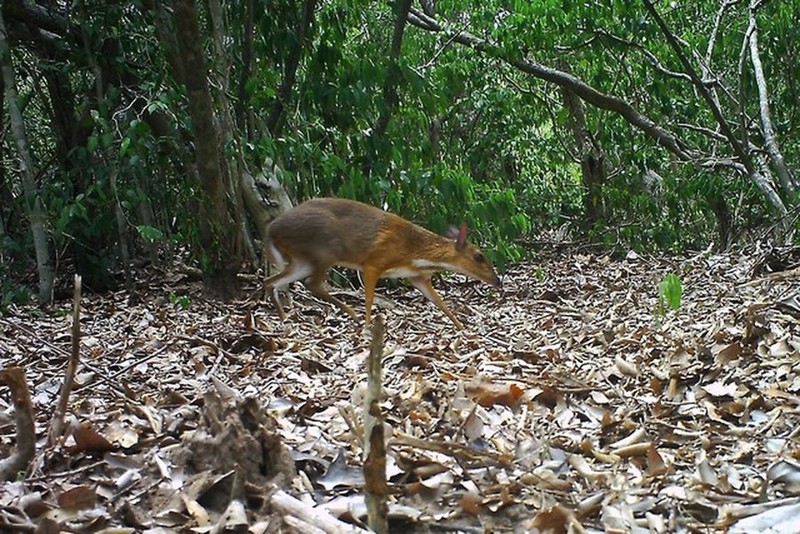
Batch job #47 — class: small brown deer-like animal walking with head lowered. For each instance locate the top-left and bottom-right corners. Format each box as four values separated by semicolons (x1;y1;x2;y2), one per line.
264;198;500;328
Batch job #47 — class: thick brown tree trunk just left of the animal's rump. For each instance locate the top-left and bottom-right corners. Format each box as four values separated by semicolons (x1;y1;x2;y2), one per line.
174;0;241;299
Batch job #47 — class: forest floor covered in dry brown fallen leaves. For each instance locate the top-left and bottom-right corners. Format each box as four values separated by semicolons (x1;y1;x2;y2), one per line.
0;247;800;533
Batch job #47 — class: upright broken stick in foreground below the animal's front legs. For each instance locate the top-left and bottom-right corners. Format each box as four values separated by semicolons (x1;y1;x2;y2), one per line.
364;315;389;534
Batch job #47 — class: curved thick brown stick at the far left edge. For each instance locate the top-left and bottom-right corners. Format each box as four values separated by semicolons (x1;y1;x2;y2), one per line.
0;366;36;480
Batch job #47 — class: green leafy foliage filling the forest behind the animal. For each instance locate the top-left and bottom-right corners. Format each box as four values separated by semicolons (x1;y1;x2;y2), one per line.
3;0;800;294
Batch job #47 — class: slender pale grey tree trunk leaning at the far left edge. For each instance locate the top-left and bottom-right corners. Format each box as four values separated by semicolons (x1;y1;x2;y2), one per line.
0;9;55;304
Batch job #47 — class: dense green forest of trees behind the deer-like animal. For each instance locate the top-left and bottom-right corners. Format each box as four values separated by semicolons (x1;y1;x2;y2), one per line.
0;0;800;304
